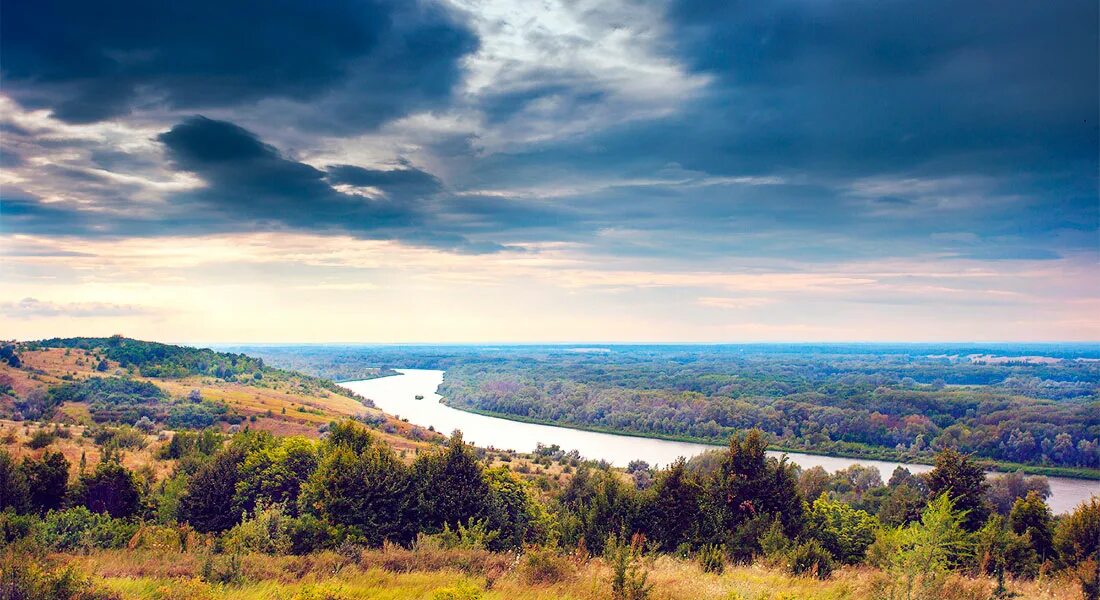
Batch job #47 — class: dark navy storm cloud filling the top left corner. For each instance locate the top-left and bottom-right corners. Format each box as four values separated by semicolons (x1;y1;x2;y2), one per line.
0;0;477;131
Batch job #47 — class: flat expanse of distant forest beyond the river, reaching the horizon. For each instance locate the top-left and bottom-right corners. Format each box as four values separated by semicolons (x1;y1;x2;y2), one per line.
234;345;1100;474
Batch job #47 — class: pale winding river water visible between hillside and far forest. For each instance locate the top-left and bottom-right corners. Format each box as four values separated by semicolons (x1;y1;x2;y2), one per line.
341;369;1100;514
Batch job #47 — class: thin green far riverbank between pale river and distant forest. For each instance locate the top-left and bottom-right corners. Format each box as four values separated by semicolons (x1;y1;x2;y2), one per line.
441;399;1100;481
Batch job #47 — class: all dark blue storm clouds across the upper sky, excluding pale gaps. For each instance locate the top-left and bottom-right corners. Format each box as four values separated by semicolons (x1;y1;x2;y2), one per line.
2;0;1100;260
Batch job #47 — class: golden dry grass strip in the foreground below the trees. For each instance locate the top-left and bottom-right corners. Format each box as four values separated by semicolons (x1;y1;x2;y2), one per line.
55;548;1081;600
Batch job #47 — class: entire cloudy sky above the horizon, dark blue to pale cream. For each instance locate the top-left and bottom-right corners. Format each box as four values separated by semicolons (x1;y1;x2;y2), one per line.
0;0;1100;342
